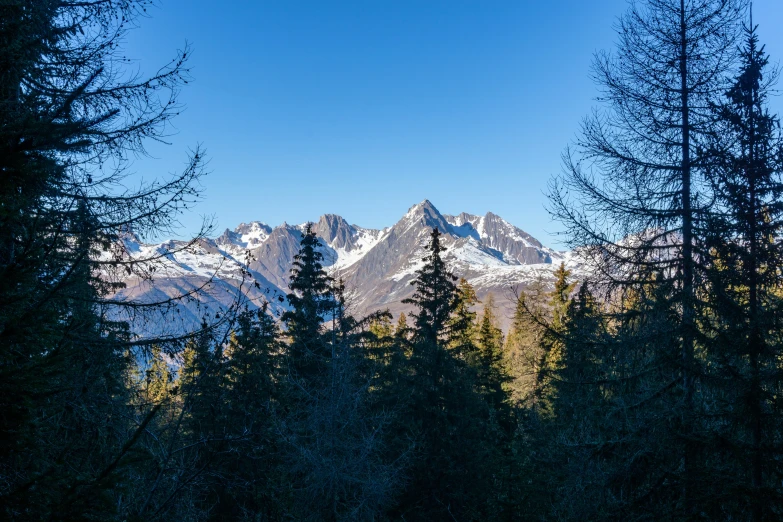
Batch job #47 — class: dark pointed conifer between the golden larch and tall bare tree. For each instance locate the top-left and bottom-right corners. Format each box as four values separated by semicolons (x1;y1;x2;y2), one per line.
536;283;617;519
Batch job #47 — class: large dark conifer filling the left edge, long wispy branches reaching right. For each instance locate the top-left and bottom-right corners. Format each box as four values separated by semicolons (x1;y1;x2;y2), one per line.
0;0;210;520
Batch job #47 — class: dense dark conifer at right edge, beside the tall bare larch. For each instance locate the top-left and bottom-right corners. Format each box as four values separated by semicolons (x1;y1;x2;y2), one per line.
702;14;783;520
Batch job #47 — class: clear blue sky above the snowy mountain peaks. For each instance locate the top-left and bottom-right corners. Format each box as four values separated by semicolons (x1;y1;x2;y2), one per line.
125;0;783;247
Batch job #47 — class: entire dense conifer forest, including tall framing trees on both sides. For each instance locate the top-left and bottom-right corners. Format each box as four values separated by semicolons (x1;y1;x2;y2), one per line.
0;0;783;521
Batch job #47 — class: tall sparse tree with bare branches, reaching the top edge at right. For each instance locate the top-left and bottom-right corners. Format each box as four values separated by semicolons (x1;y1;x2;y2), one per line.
551;0;746;518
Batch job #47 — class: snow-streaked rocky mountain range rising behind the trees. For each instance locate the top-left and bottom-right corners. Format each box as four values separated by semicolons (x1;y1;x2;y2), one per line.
118;200;580;326
